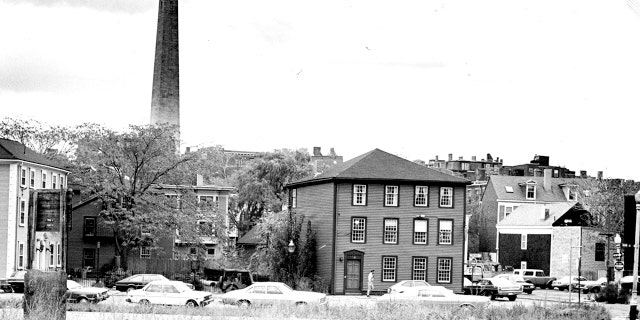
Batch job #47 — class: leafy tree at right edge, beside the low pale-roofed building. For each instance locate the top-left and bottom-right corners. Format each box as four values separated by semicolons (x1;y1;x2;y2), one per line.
571;179;640;234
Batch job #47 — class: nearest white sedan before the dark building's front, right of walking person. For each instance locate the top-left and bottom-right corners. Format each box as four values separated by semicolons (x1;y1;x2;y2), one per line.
377;286;489;308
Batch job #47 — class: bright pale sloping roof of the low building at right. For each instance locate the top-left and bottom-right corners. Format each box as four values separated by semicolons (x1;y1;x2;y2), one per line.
496;201;577;227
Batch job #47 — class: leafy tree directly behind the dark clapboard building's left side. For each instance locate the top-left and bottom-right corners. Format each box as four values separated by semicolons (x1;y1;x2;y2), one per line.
233;150;312;227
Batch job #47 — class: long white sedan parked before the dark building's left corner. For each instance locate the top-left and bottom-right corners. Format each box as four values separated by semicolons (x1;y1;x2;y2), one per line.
222;282;327;306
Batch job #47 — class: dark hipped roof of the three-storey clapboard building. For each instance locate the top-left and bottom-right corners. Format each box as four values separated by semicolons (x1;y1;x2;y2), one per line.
288;149;471;186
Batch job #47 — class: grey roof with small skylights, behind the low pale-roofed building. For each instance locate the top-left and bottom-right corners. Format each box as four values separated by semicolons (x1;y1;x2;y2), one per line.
488;175;574;202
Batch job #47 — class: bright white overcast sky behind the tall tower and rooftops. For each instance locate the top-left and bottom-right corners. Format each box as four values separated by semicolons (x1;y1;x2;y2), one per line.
0;0;640;180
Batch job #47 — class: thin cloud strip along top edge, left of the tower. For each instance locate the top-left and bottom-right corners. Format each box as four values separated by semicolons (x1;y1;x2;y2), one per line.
2;0;158;13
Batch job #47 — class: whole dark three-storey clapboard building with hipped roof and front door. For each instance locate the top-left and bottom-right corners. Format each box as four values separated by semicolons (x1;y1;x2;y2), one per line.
287;149;470;294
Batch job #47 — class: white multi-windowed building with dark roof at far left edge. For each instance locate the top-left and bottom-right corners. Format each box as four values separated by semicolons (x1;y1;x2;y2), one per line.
0;138;69;278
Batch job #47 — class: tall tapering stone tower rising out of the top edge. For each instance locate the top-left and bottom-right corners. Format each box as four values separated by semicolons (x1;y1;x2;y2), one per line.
151;0;180;141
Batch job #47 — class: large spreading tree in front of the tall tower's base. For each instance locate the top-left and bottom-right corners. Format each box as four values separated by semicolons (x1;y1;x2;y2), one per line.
74;125;224;261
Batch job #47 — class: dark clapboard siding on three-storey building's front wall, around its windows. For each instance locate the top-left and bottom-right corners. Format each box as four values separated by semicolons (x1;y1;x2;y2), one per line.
332;183;466;294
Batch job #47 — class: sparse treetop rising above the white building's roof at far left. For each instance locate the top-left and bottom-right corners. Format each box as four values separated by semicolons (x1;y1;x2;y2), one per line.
0;117;76;164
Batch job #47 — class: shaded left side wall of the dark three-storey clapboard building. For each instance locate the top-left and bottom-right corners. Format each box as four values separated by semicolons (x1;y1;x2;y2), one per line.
294;183;334;283
